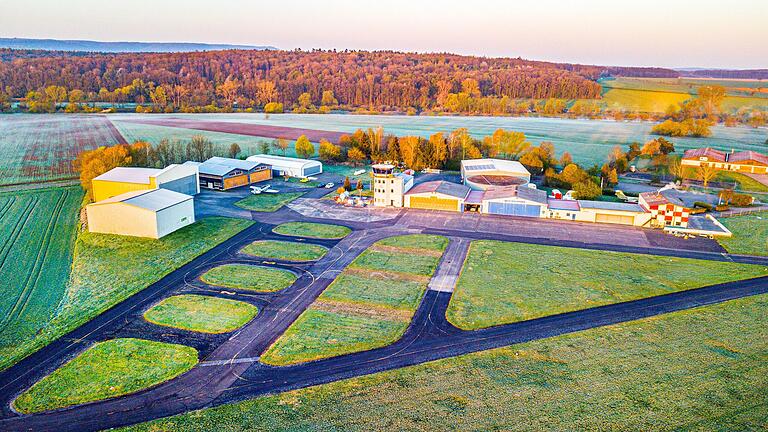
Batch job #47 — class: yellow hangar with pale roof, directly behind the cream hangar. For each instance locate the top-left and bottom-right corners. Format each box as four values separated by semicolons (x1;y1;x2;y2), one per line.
91;164;200;201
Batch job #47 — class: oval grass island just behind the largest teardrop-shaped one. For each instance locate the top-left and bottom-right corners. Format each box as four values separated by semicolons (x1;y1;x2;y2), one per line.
144;294;258;333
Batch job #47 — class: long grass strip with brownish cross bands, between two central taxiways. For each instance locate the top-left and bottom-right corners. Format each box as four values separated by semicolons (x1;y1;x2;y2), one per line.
261;234;448;365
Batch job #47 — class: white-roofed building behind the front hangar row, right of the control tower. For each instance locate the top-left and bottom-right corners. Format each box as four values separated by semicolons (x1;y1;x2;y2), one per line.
461;159;531;190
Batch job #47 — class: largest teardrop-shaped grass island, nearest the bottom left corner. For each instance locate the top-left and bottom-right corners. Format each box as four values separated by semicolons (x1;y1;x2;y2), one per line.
14;339;197;413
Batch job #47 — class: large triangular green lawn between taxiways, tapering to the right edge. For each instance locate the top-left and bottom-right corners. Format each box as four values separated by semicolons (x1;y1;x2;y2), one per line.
446;240;768;330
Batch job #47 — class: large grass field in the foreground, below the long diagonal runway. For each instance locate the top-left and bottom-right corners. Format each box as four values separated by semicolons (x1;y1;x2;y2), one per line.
123;295;768;432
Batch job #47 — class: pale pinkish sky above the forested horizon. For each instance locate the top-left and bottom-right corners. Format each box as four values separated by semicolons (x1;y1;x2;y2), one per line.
0;0;768;69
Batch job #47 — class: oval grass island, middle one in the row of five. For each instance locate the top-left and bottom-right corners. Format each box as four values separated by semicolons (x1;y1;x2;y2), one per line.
200;264;296;292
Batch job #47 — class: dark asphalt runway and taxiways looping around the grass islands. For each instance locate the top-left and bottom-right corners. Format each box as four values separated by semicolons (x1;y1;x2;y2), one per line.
0;197;768;432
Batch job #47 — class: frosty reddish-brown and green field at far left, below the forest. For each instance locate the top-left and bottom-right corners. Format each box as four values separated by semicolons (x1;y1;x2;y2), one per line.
0;114;126;185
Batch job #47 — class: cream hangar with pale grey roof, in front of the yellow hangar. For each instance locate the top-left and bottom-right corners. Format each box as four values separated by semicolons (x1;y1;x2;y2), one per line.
85;189;195;239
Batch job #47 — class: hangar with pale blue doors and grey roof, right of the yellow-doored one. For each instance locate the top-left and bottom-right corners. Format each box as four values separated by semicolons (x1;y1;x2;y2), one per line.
482;186;547;217
